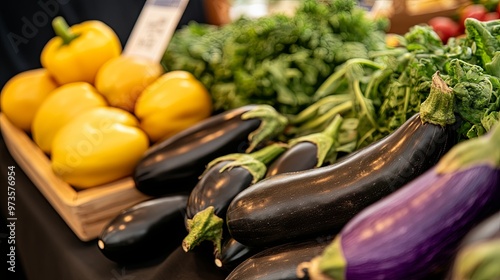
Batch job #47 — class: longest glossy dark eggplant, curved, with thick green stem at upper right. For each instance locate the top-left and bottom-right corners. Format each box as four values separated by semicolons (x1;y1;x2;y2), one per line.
226;72;458;247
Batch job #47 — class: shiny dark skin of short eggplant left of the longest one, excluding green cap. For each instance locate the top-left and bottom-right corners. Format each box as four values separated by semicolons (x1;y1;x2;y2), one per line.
186;161;253;222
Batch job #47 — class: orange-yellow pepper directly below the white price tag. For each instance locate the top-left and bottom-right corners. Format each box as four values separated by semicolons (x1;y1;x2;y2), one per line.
95;55;164;113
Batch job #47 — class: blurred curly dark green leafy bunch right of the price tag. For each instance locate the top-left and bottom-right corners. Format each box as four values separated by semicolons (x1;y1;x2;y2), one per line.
162;0;387;114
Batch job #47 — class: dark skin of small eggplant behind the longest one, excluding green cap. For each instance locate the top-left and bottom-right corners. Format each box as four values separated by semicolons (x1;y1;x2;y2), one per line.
266;141;318;177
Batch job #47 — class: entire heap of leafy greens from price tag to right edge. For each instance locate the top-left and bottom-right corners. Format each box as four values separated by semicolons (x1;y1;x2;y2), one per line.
162;0;500;152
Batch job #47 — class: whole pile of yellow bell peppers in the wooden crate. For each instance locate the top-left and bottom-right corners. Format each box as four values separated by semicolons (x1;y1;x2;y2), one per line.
0;17;212;189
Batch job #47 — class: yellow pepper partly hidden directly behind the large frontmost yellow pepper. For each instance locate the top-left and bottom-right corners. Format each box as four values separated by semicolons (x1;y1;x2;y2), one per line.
31;82;108;154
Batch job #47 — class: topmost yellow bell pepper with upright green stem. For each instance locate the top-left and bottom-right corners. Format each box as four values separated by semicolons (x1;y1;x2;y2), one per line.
40;17;122;84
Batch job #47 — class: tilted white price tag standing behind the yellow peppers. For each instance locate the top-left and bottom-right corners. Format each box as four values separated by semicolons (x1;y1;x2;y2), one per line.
123;0;189;61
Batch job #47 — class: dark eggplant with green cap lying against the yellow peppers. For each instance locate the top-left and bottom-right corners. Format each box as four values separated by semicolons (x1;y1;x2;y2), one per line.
133;105;287;196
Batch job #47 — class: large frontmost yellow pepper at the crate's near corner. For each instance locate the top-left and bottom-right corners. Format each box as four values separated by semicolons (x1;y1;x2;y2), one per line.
51;107;149;189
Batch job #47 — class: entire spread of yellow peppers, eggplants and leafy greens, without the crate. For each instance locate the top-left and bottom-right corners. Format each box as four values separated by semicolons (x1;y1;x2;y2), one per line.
1;0;500;280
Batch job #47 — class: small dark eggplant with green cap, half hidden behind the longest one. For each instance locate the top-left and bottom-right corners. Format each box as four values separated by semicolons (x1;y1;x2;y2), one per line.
266;115;343;177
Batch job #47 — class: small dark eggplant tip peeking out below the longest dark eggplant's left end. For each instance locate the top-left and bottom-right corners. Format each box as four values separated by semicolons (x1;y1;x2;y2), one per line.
215;238;263;271
